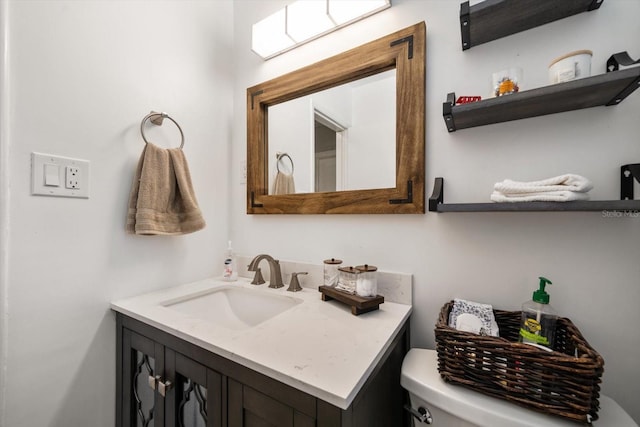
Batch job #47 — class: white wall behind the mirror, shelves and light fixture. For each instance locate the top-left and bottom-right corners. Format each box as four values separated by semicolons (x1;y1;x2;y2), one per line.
231;0;640;422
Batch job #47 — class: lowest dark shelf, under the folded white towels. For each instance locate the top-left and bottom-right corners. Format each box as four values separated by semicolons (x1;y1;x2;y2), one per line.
429;178;640;216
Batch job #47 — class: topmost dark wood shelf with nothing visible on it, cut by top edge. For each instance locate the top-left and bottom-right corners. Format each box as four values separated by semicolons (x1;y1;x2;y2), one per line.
460;0;604;50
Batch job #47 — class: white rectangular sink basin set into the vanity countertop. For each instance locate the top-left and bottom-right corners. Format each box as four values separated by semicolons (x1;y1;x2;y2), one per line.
162;286;302;330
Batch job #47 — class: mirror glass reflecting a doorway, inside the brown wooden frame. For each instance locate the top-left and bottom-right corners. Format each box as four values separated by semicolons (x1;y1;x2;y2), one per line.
267;69;396;194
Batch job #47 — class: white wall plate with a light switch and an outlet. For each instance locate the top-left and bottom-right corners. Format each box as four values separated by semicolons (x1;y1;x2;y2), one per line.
31;153;89;199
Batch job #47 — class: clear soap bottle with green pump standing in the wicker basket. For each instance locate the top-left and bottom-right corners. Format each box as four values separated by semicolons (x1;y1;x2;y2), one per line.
519;277;558;351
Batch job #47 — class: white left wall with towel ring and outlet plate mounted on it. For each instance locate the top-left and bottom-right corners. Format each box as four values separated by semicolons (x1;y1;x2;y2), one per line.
0;0;234;427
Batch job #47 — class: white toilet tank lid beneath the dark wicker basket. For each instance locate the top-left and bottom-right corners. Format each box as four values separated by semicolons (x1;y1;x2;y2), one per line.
400;348;638;427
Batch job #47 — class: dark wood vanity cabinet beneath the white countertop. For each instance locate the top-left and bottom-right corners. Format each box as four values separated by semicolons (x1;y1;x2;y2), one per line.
116;312;410;427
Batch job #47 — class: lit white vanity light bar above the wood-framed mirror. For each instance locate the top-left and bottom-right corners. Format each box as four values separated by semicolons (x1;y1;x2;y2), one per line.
251;0;391;59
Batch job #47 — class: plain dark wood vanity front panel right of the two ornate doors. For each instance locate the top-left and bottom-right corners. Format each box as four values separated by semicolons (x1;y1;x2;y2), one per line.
227;378;316;427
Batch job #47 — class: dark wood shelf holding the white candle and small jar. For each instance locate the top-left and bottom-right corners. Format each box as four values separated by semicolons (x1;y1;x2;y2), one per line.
442;67;640;132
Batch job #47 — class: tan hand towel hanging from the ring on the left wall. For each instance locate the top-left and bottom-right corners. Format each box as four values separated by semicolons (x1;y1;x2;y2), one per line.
126;143;205;235
